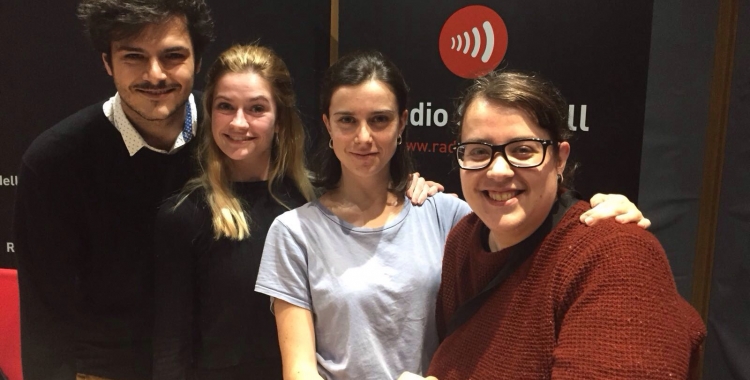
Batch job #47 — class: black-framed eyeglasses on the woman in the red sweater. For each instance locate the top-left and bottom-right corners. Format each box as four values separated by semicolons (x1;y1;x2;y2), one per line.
453;139;555;170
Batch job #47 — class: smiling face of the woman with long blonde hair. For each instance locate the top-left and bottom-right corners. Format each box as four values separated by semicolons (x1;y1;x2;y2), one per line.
211;72;276;181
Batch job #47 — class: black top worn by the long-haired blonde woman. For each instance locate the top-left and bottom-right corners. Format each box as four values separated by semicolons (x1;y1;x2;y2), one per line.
154;180;306;380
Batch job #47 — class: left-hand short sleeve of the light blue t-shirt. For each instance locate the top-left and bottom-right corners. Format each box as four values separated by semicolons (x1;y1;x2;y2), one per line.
255;214;312;310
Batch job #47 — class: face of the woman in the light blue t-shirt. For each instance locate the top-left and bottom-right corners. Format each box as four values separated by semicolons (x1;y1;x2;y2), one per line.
323;80;406;183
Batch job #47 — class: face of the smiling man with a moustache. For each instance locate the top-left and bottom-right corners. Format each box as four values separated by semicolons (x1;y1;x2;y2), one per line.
102;16;196;125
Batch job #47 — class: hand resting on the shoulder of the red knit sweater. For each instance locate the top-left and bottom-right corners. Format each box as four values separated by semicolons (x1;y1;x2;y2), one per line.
580;194;651;229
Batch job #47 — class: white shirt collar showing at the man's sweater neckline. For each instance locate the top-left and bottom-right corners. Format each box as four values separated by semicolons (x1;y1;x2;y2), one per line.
102;93;198;157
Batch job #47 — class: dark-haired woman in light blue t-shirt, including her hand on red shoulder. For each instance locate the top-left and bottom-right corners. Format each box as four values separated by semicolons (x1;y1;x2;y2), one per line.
255;52;641;379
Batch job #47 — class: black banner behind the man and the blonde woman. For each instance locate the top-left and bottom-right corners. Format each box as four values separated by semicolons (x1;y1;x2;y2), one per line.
0;0;331;267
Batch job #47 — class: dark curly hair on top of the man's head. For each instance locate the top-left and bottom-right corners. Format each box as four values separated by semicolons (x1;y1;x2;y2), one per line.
78;0;214;61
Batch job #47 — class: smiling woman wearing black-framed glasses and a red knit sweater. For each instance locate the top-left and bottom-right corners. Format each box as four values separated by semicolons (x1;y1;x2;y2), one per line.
428;72;705;380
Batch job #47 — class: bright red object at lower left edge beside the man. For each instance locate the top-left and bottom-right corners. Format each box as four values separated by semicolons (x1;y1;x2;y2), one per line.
0;268;22;380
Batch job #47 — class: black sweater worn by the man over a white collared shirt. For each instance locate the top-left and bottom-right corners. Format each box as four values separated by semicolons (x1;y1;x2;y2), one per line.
14;103;201;380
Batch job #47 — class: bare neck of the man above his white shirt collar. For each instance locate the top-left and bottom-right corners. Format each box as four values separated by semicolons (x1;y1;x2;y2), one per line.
122;102;187;150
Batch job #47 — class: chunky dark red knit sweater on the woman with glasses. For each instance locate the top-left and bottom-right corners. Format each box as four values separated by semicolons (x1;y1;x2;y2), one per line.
428;202;705;380
